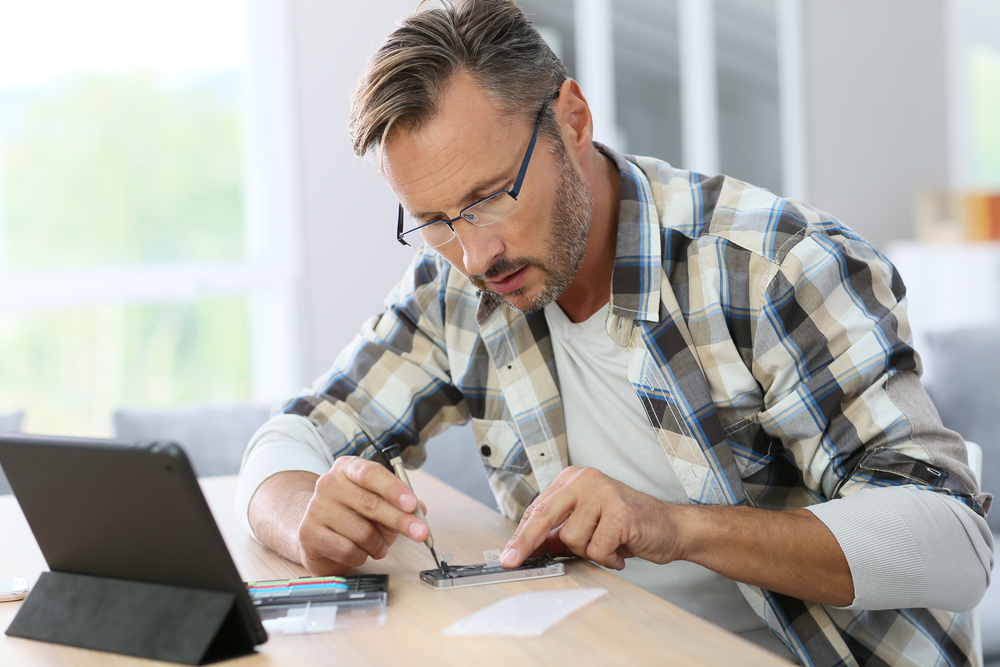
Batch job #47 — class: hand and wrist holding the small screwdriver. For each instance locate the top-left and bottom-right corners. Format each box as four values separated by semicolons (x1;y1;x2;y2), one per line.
249;456;430;575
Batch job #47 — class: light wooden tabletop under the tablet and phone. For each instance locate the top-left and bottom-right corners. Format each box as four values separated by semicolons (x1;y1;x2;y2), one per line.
0;471;789;667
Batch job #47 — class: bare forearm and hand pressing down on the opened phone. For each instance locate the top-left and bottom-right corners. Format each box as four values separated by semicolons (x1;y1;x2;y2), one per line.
500;467;854;607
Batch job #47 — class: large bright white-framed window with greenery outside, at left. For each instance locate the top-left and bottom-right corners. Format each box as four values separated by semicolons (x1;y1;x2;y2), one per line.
0;0;295;435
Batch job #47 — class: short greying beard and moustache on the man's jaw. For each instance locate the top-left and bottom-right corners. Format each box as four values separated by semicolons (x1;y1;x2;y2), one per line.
469;141;594;314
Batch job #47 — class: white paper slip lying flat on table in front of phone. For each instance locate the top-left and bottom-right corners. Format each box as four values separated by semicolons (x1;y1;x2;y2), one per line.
442;588;608;637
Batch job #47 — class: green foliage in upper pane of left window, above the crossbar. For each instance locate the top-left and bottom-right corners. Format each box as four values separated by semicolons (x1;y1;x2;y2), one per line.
0;69;244;270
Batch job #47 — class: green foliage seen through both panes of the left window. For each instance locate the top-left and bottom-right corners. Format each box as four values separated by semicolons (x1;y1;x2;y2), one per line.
0;69;251;435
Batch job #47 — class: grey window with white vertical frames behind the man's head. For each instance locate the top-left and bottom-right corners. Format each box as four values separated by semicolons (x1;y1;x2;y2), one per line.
519;0;804;197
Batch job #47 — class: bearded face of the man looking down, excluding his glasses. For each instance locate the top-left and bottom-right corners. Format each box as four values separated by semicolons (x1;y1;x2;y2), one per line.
384;74;593;312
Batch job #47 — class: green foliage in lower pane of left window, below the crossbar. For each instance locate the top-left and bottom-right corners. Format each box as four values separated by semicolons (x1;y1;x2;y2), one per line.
0;297;251;436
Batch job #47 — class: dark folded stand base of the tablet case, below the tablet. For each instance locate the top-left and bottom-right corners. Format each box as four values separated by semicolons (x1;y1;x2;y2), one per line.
7;572;254;665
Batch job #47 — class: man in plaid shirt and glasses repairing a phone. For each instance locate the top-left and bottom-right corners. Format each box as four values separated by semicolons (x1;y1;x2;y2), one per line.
238;0;993;665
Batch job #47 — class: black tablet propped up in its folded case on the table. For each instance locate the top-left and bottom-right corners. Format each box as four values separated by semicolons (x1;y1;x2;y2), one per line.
0;435;267;665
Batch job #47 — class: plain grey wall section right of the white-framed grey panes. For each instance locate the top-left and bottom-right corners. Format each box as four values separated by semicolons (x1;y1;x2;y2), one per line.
802;0;948;247
